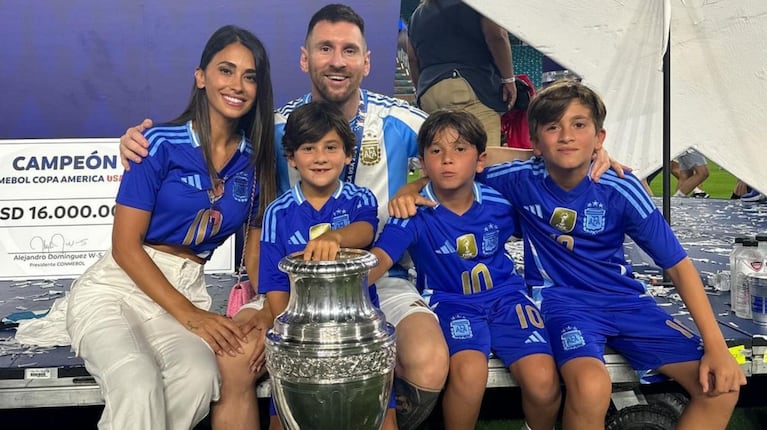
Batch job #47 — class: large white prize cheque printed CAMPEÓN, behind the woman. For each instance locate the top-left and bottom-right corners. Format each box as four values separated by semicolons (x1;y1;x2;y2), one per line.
0;139;234;280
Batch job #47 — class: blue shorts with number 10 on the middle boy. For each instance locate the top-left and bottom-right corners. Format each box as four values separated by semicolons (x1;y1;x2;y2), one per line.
436;288;551;367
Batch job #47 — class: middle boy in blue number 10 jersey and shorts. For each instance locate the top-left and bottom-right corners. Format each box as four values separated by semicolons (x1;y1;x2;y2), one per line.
368;110;560;430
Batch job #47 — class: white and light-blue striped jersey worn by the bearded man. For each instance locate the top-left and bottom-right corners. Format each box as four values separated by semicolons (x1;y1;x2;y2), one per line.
274;90;426;237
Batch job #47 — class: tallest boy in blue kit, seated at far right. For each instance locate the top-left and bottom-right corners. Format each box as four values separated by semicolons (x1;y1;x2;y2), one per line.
480;81;746;430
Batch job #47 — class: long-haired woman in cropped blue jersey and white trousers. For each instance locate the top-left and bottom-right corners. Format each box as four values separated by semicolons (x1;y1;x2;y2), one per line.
67;26;274;429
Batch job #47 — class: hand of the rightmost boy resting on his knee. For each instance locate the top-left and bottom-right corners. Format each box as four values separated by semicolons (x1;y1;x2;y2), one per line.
698;348;746;396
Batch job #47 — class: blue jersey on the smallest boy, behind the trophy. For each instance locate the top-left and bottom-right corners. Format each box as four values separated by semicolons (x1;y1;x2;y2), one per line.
258;181;378;294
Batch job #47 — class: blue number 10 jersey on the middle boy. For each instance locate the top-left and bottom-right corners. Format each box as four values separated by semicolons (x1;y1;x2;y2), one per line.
376;183;525;300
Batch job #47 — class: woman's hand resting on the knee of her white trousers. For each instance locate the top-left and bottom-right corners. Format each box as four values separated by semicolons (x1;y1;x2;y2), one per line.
179;308;245;357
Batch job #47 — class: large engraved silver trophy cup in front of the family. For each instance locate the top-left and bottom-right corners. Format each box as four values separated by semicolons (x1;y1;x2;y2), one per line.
266;249;396;430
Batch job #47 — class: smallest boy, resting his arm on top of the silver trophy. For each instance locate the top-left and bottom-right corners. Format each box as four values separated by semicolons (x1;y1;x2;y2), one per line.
226;101;397;430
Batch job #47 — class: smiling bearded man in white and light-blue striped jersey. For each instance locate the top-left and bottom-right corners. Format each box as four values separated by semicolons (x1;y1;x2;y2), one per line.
120;4;448;429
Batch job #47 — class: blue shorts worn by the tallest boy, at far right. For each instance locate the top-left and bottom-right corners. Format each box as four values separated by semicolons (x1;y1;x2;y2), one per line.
543;299;703;377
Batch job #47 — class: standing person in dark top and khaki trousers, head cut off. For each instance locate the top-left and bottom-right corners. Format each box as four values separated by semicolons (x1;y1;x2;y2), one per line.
408;0;517;146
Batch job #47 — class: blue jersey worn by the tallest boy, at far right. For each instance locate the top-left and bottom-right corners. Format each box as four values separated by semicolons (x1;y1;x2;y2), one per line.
478;158;686;309
